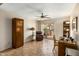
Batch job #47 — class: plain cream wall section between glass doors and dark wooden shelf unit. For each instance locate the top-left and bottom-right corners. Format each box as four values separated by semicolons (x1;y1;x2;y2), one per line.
54;20;63;40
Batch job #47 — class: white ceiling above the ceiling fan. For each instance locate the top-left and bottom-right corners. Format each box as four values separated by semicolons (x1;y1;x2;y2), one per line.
0;3;76;18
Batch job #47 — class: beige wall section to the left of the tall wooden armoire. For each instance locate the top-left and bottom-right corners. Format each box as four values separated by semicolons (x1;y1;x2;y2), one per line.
0;10;12;51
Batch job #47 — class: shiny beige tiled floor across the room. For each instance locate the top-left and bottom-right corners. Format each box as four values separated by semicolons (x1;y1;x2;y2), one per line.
0;39;57;56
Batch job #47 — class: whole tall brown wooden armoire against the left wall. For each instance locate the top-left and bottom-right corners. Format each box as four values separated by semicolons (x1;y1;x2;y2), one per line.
12;18;24;48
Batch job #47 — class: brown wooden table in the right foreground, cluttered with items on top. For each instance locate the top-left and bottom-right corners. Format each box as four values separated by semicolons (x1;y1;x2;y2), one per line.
58;40;77;56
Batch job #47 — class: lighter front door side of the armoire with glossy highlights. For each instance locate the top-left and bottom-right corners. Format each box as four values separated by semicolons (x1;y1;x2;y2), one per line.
16;20;23;47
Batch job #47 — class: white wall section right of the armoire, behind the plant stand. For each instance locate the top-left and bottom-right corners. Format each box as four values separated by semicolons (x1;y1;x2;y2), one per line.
24;20;36;42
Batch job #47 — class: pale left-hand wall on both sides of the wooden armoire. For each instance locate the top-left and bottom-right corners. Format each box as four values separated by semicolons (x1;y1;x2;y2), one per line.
0;9;36;51
